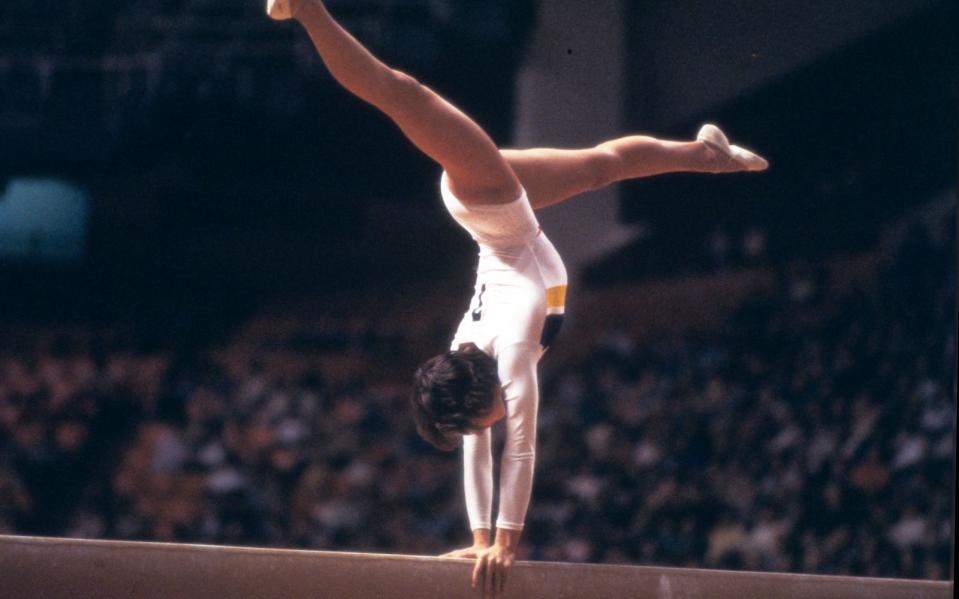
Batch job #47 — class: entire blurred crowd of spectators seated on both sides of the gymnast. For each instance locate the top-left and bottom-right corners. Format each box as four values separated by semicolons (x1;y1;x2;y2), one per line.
0;211;956;579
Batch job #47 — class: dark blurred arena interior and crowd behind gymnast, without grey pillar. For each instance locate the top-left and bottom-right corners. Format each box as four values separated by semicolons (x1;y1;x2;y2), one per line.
0;0;959;579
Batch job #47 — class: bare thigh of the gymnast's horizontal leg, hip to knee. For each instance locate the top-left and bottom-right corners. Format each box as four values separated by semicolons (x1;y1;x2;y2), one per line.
500;148;617;208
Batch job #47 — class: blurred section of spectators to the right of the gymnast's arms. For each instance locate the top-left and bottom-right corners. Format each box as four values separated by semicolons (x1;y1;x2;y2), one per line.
529;218;956;578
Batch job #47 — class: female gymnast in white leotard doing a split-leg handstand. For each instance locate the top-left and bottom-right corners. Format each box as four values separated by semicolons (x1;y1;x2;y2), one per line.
267;0;768;594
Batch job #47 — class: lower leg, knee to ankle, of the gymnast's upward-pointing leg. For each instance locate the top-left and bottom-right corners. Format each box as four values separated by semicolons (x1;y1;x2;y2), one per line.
296;0;398;105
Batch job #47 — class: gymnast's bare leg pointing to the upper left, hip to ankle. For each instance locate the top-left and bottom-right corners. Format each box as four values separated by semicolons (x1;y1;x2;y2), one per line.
291;0;520;204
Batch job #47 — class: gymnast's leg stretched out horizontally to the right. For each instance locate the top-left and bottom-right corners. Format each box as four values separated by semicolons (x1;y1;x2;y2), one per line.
501;130;764;208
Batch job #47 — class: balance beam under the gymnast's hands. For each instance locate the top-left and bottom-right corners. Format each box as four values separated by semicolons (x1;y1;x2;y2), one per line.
0;535;953;599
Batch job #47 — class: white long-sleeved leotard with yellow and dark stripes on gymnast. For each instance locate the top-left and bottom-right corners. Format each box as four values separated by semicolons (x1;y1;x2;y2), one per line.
440;173;567;530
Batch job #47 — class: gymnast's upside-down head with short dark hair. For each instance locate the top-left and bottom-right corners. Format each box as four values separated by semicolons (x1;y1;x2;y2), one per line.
410;343;500;451
